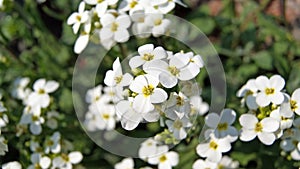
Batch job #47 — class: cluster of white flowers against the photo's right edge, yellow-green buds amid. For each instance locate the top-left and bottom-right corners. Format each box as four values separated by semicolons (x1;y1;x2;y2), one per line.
237;75;300;160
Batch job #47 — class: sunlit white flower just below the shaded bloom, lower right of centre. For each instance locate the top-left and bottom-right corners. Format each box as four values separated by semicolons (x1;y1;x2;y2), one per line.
196;133;231;162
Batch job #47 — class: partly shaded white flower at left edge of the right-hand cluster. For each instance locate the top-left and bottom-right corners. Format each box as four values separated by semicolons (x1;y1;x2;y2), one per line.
236;79;258;110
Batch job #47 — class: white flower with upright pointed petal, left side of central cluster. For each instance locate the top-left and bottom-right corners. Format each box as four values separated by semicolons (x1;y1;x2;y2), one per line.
104;57;133;87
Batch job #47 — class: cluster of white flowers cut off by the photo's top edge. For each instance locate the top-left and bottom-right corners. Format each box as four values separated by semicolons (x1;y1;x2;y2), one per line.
67;0;185;53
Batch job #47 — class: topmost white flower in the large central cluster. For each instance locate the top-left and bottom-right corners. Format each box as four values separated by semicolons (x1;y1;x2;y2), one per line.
129;44;167;69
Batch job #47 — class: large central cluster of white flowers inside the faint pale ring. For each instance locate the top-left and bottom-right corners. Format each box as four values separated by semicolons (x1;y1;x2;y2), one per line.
85;44;208;140
